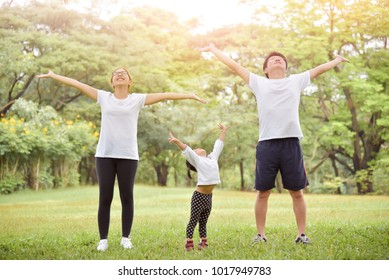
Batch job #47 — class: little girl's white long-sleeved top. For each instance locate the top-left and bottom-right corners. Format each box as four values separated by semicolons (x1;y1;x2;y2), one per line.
182;139;224;186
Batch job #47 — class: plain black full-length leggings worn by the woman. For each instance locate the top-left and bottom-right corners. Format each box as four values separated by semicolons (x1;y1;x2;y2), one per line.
96;158;138;239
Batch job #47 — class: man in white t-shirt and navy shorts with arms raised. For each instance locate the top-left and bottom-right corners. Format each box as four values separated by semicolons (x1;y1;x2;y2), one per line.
200;44;349;244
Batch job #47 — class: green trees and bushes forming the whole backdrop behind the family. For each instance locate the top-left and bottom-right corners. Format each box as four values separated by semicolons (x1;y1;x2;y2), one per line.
0;0;389;194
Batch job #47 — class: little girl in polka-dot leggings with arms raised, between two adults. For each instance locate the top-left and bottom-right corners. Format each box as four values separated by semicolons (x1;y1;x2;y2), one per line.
169;124;228;251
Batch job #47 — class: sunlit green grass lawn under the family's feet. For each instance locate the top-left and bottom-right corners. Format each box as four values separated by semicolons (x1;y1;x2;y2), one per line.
0;185;389;260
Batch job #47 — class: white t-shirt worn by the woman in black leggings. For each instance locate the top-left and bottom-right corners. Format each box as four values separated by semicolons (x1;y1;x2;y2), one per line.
95;90;146;160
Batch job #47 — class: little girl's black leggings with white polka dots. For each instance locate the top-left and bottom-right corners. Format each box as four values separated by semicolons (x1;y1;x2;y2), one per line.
186;191;212;239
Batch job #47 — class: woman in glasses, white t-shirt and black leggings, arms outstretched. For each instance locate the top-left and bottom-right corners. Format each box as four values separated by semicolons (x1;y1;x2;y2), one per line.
36;68;206;251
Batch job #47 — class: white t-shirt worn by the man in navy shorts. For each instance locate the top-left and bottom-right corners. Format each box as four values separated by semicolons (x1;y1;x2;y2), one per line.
249;71;310;141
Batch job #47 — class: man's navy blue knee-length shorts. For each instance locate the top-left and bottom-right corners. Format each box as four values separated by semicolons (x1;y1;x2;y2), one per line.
255;138;309;191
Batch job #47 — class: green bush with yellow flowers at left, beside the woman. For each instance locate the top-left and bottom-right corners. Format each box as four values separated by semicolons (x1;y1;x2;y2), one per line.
0;99;98;193
